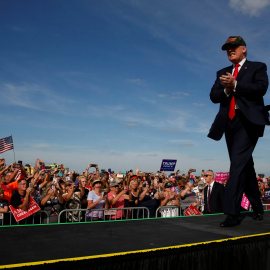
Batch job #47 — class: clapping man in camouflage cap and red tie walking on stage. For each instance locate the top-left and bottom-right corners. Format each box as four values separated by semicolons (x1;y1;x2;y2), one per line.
208;36;270;227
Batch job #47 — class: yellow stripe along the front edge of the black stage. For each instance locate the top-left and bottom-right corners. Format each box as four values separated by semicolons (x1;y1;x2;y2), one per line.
0;233;270;269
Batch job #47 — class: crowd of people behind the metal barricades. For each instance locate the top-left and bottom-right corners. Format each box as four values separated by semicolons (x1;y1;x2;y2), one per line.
0;159;270;225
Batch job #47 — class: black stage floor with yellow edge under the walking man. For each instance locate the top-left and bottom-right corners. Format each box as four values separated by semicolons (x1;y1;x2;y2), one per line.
0;211;270;269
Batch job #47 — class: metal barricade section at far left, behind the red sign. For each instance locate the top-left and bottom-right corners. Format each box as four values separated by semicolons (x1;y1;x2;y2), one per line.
0;210;50;226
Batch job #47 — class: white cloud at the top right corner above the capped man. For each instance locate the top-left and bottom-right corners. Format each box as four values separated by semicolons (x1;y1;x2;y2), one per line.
229;0;270;16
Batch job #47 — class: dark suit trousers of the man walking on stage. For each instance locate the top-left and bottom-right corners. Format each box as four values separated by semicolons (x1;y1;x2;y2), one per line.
224;110;264;215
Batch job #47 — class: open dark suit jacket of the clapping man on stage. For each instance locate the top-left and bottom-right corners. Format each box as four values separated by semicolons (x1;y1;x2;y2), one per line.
208;60;270;141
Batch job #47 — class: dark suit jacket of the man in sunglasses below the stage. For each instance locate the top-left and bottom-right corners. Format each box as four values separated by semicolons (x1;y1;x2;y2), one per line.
203;182;225;214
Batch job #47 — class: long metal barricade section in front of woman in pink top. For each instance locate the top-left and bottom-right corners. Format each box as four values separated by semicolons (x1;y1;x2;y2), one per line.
58;207;150;223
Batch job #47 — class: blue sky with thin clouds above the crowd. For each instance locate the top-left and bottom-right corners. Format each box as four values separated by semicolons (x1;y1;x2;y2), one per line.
0;0;270;175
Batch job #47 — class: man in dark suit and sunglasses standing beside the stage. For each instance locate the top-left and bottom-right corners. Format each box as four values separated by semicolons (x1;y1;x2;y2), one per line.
203;170;224;214
